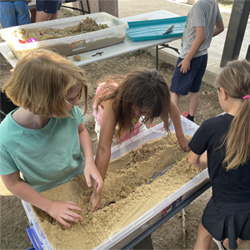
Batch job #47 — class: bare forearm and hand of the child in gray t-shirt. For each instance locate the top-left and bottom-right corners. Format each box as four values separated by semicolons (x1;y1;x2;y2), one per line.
178;27;205;74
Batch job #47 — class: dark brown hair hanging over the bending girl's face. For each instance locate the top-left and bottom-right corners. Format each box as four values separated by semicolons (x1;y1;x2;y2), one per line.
95;69;170;141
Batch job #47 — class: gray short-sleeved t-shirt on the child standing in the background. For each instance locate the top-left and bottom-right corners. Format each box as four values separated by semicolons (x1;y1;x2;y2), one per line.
180;0;222;58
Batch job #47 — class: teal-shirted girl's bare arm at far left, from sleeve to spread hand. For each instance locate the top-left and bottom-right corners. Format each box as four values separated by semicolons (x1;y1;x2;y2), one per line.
1;171;82;227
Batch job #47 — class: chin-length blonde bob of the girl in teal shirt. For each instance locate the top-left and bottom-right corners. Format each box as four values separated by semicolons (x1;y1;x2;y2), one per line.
2;49;88;118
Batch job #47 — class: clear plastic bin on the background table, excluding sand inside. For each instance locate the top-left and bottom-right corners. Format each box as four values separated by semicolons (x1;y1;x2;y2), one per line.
0;12;128;59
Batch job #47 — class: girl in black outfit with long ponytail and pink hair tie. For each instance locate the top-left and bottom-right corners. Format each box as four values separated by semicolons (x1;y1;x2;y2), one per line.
188;60;250;250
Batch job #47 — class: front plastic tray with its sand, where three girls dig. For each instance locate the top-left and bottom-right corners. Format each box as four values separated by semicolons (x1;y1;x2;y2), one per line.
23;118;208;250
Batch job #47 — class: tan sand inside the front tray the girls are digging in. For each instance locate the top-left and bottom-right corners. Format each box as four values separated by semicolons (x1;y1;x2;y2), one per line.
34;135;200;250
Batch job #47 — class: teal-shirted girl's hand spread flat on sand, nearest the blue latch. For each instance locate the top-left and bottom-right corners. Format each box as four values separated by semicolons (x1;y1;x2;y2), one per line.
46;201;82;227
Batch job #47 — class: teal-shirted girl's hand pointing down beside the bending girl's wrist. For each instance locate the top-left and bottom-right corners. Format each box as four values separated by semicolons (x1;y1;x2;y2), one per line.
84;161;103;193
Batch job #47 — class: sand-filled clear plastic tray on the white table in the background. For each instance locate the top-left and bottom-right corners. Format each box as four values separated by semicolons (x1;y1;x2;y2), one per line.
0;12;127;59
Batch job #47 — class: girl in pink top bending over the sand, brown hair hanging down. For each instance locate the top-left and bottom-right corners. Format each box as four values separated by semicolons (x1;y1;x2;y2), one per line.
90;69;189;211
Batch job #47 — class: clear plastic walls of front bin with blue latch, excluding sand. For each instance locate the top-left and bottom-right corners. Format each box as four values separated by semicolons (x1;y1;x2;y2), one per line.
22;116;209;250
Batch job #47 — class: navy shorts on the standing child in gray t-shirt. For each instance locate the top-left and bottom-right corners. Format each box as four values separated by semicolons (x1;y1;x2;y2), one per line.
170;54;207;95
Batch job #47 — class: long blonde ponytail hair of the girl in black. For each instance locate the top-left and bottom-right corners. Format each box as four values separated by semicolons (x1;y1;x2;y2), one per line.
215;60;250;170
